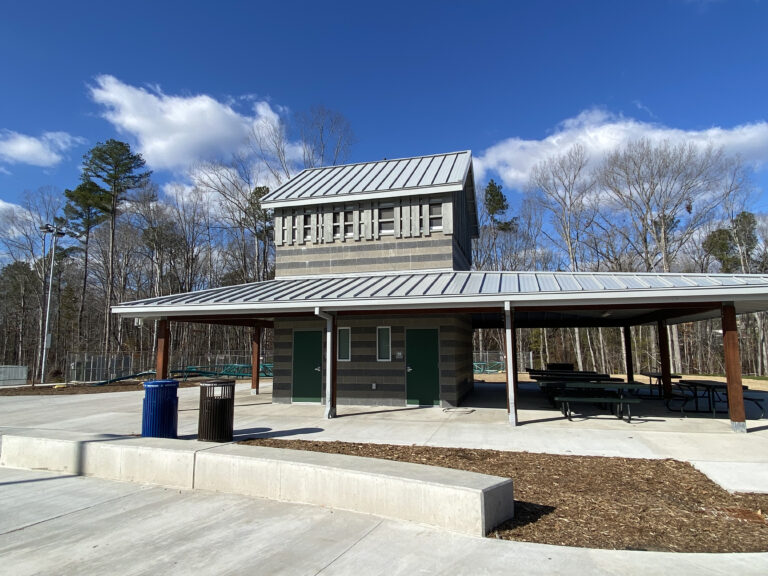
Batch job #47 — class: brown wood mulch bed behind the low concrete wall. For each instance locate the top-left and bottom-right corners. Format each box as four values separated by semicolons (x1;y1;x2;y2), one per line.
243;439;768;552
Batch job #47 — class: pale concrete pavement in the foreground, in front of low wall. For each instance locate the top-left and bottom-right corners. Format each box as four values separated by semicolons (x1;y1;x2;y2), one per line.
0;468;768;576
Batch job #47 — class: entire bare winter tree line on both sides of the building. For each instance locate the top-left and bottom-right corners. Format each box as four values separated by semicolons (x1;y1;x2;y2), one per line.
0;126;768;379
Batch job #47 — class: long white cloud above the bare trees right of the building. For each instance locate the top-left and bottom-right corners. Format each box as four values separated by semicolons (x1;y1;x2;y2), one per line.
474;108;768;189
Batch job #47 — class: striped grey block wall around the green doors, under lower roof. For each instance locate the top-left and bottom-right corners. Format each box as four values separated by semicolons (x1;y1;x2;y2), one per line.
273;314;472;407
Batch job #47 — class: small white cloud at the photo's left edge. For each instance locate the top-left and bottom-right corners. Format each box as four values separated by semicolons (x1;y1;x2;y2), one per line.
0;130;85;166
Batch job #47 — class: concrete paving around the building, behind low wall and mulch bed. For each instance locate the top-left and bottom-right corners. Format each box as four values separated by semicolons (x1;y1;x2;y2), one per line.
0;382;768;492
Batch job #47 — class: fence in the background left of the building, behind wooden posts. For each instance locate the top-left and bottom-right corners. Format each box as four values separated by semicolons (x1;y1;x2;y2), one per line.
66;350;272;382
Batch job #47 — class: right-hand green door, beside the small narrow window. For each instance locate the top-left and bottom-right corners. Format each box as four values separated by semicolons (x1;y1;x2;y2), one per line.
405;329;440;406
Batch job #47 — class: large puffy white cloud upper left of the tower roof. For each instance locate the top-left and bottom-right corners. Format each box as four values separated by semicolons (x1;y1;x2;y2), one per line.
90;75;288;170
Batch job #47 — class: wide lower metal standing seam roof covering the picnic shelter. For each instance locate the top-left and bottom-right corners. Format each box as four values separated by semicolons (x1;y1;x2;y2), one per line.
112;270;768;317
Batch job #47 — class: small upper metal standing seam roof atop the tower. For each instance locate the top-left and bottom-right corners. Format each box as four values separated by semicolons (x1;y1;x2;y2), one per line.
261;150;472;208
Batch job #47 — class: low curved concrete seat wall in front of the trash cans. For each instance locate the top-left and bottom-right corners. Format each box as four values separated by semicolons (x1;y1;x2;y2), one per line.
0;430;514;536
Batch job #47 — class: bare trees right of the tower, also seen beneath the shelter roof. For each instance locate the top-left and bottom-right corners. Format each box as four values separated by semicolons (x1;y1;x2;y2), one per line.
474;139;768;374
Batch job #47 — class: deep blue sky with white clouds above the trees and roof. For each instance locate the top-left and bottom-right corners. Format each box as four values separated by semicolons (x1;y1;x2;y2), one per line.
0;0;768;210
